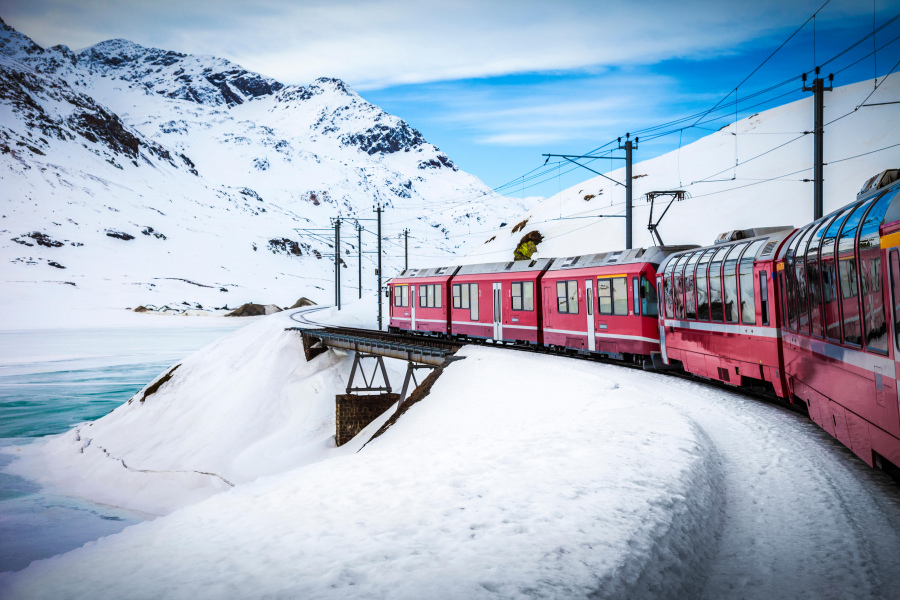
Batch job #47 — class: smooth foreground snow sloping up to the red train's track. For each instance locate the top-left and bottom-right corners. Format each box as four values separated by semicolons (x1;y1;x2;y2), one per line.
7;340;900;599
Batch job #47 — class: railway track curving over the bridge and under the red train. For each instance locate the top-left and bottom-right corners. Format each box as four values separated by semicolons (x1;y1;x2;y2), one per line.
291;307;809;418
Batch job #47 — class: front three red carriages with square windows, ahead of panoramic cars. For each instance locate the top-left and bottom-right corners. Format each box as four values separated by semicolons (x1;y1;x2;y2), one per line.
388;246;693;361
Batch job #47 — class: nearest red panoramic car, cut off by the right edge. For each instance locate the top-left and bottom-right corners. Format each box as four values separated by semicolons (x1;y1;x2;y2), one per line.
778;170;900;467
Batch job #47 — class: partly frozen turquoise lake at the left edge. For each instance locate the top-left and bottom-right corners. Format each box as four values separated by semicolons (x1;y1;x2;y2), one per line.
0;324;247;572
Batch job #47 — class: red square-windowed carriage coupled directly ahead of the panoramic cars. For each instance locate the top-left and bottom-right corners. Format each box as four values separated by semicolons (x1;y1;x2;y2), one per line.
541;246;695;359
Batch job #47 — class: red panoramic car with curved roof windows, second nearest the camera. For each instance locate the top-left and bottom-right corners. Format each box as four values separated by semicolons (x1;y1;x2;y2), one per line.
657;227;794;397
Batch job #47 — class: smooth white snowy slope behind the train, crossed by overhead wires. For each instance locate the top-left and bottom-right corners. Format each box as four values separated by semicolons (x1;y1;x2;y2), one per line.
472;74;900;263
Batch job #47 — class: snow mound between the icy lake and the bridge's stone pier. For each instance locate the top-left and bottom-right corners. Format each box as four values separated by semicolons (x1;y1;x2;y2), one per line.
4;309;405;515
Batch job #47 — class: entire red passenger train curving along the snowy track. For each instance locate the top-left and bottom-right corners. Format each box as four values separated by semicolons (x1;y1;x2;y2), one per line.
388;169;900;476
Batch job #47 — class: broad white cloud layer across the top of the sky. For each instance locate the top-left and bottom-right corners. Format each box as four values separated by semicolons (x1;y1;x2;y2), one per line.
2;0;868;90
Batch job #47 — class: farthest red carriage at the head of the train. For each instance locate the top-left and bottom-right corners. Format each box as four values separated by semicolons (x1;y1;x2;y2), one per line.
387;267;459;334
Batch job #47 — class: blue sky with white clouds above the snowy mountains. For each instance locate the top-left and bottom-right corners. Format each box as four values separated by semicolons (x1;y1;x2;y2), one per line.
7;0;900;196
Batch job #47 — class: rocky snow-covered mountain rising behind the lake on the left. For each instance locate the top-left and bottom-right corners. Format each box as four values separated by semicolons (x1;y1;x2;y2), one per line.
0;21;527;327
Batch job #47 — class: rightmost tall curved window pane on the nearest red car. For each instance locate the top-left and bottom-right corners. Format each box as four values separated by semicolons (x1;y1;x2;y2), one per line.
858;192;897;354
